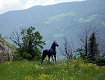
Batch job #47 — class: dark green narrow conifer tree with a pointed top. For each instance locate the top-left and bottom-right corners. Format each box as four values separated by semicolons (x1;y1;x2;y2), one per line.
87;32;99;60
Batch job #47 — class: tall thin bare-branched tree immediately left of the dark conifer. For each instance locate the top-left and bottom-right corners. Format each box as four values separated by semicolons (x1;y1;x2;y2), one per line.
77;25;100;58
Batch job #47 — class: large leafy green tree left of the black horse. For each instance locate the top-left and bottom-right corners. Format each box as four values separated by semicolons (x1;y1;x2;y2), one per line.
10;27;45;60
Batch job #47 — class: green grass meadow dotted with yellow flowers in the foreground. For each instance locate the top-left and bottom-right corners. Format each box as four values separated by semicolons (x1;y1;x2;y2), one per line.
0;59;105;80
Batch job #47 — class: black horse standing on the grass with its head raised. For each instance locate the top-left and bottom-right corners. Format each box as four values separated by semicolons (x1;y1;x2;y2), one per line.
42;41;59;63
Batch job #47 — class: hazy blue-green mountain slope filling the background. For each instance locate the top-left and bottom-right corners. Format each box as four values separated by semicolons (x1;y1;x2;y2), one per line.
0;0;105;53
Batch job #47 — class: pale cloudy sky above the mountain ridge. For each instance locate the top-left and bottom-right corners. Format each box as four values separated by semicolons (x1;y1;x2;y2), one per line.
0;0;84;14
